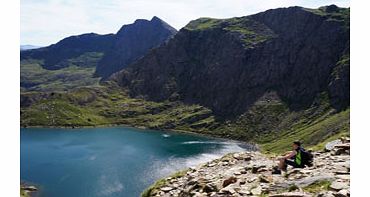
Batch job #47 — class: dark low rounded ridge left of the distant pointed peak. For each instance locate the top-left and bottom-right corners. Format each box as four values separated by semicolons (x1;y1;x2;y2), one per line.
21;33;114;70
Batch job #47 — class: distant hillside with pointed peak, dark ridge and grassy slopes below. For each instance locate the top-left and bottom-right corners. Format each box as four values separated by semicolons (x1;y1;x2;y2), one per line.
21;17;176;91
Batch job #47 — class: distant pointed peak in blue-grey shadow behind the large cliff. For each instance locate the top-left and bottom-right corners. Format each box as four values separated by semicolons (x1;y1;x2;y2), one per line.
96;17;177;78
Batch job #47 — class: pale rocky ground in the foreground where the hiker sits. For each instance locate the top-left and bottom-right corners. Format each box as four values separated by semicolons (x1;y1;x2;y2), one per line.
143;139;350;197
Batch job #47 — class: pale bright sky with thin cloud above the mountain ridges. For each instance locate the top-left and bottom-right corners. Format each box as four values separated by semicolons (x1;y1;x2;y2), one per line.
20;0;349;46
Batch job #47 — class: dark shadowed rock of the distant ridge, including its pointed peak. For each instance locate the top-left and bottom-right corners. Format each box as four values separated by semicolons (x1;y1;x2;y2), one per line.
21;17;177;78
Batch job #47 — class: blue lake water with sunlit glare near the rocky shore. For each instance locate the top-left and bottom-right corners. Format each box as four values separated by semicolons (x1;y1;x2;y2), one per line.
21;127;254;197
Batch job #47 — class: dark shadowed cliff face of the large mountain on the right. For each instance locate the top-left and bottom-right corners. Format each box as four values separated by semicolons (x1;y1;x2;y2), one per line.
112;6;349;116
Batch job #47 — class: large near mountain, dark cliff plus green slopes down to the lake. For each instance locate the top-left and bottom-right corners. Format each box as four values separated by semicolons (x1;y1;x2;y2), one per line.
21;5;350;154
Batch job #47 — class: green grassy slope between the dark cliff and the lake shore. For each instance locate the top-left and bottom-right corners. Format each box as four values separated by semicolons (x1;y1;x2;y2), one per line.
21;85;350;153
